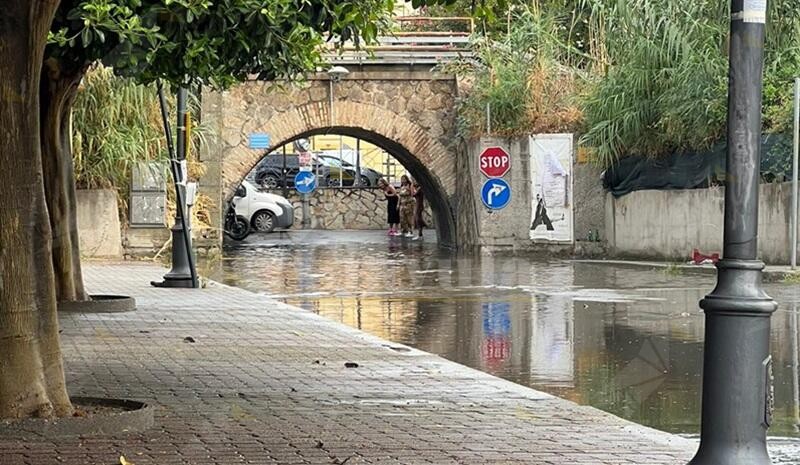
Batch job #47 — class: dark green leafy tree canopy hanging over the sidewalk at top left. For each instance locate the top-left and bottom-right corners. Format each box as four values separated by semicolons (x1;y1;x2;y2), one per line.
47;0;394;88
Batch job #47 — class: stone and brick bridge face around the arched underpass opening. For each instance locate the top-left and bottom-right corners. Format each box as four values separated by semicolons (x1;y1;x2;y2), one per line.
201;71;458;243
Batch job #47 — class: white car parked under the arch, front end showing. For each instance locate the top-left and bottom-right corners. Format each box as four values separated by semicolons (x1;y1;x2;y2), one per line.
235;180;294;232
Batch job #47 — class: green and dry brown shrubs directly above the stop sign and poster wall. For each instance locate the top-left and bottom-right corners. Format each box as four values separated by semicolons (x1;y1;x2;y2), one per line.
444;7;584;138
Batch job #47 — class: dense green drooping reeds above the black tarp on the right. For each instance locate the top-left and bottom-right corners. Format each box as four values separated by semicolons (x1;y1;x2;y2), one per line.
582;0;800;166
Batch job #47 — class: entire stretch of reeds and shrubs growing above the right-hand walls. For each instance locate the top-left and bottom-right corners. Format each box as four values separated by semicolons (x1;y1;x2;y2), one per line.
438;0;800;167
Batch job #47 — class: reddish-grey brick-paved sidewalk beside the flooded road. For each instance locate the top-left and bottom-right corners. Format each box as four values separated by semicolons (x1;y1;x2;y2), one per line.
0;263;696;465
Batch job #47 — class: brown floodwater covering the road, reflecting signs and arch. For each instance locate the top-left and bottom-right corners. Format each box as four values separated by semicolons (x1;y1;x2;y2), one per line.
223;231;800;456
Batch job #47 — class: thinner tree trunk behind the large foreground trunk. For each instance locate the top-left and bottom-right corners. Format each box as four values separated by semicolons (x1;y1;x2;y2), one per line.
39;59;89;302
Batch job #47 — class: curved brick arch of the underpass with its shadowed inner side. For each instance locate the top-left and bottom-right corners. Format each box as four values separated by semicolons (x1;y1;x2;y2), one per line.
222;101;457;246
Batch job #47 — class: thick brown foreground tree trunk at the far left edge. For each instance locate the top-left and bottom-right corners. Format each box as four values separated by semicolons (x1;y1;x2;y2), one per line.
0;0;72;418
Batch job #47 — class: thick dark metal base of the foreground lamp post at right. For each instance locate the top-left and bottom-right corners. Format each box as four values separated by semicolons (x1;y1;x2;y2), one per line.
689;259;777;465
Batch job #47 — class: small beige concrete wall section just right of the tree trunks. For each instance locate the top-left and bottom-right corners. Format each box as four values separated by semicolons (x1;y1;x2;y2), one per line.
77;190;122;258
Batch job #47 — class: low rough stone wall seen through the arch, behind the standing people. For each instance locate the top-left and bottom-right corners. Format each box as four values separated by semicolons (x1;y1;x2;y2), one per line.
274;188;435;230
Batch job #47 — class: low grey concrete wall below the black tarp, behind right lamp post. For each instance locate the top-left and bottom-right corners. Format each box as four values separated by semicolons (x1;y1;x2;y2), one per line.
605;183;791;264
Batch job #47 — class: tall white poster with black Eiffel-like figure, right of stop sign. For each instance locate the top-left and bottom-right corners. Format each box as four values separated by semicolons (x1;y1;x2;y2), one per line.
530;134;575;242
